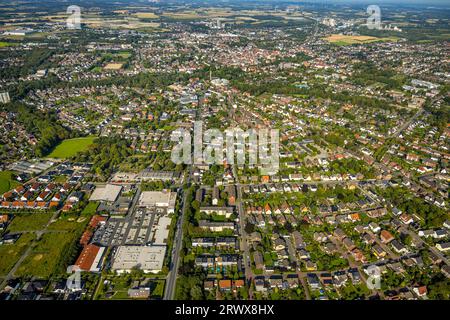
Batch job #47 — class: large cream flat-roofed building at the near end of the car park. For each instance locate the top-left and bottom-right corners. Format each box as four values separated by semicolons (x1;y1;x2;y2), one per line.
111;246;166;273
